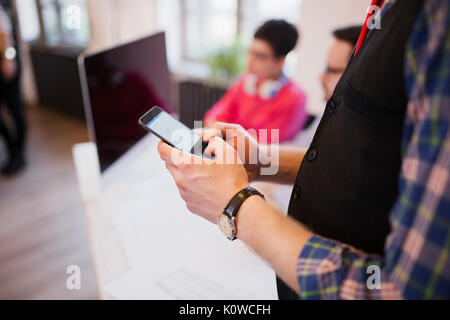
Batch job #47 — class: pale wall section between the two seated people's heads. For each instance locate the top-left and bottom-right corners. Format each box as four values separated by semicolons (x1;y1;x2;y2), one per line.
295;0;370;114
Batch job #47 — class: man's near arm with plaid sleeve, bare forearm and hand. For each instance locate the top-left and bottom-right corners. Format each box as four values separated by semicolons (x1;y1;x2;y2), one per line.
160;0;450;299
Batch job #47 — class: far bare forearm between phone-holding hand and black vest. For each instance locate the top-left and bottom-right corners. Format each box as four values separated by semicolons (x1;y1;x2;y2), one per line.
255;146;306;184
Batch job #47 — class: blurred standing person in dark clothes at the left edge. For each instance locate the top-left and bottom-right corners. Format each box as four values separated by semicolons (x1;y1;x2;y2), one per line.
0;4;26;175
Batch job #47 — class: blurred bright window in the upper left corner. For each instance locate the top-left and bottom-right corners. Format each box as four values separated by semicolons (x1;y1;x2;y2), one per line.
17;0;90;47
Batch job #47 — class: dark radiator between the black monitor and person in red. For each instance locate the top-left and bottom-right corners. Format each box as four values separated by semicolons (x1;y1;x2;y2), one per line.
178;80;226;129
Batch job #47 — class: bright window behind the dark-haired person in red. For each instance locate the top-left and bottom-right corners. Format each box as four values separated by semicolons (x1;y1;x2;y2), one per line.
181;0;300;61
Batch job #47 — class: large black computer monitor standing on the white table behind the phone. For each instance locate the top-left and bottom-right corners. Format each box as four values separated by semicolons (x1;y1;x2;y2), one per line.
79;32;171;171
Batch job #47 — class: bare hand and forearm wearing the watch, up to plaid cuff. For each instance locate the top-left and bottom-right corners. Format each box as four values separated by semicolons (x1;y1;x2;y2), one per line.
158;137;312;291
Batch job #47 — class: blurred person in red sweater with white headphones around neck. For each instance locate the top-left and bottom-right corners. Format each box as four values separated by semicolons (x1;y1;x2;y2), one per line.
204;20;307;143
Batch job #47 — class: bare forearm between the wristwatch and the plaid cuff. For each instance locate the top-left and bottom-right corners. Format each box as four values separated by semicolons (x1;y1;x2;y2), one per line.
237;196;313;292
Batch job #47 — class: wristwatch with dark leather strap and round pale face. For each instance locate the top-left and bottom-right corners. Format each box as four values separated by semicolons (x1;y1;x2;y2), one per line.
217;187;265;241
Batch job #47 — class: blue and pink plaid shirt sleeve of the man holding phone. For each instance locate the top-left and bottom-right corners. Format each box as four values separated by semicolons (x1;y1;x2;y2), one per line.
297;0;450;299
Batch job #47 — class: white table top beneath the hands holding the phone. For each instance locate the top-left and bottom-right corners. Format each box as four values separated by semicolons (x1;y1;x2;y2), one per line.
74;135;290;299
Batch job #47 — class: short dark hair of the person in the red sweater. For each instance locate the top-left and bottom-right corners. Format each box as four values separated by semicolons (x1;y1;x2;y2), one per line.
255;20;299;58
